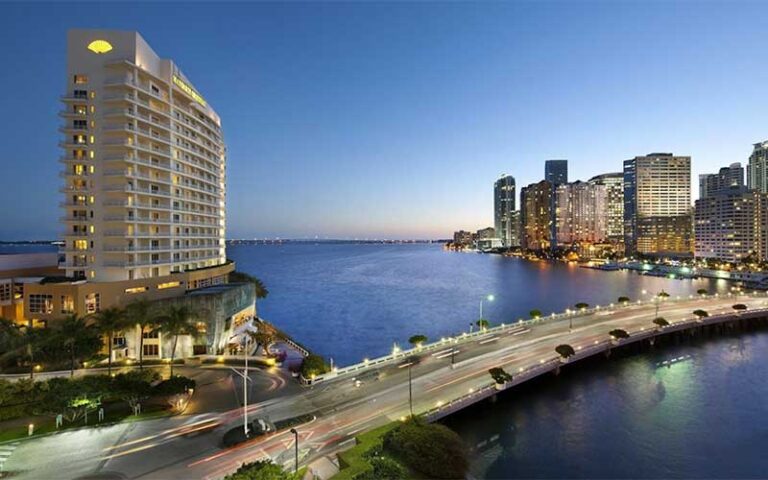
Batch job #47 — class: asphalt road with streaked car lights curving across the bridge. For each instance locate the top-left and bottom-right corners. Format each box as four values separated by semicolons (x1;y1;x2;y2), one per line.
6;294;768;478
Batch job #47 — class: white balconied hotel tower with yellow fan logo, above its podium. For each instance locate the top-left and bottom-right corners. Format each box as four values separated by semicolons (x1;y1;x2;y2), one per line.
60;30;226;282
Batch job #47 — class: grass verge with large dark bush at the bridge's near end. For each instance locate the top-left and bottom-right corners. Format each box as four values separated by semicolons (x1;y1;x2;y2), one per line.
333;418;469;480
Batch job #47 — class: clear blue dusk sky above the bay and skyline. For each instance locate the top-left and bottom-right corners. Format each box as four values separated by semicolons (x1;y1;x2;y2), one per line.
0;1;768;240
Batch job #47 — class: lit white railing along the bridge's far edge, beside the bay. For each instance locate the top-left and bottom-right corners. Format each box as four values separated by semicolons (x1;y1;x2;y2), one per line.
307;291;768;384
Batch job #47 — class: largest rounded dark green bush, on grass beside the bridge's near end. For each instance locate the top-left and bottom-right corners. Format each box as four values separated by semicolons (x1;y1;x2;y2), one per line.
384;419;469;478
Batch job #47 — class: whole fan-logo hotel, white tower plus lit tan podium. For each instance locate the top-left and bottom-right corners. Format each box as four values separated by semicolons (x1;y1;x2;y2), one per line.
0;30;255;358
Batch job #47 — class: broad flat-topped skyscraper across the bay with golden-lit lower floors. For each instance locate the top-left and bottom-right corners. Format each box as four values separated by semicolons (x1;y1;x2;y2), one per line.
624;153;692;255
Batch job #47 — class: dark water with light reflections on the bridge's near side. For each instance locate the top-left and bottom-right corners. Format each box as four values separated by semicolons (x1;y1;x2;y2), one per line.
446;332;768;478
